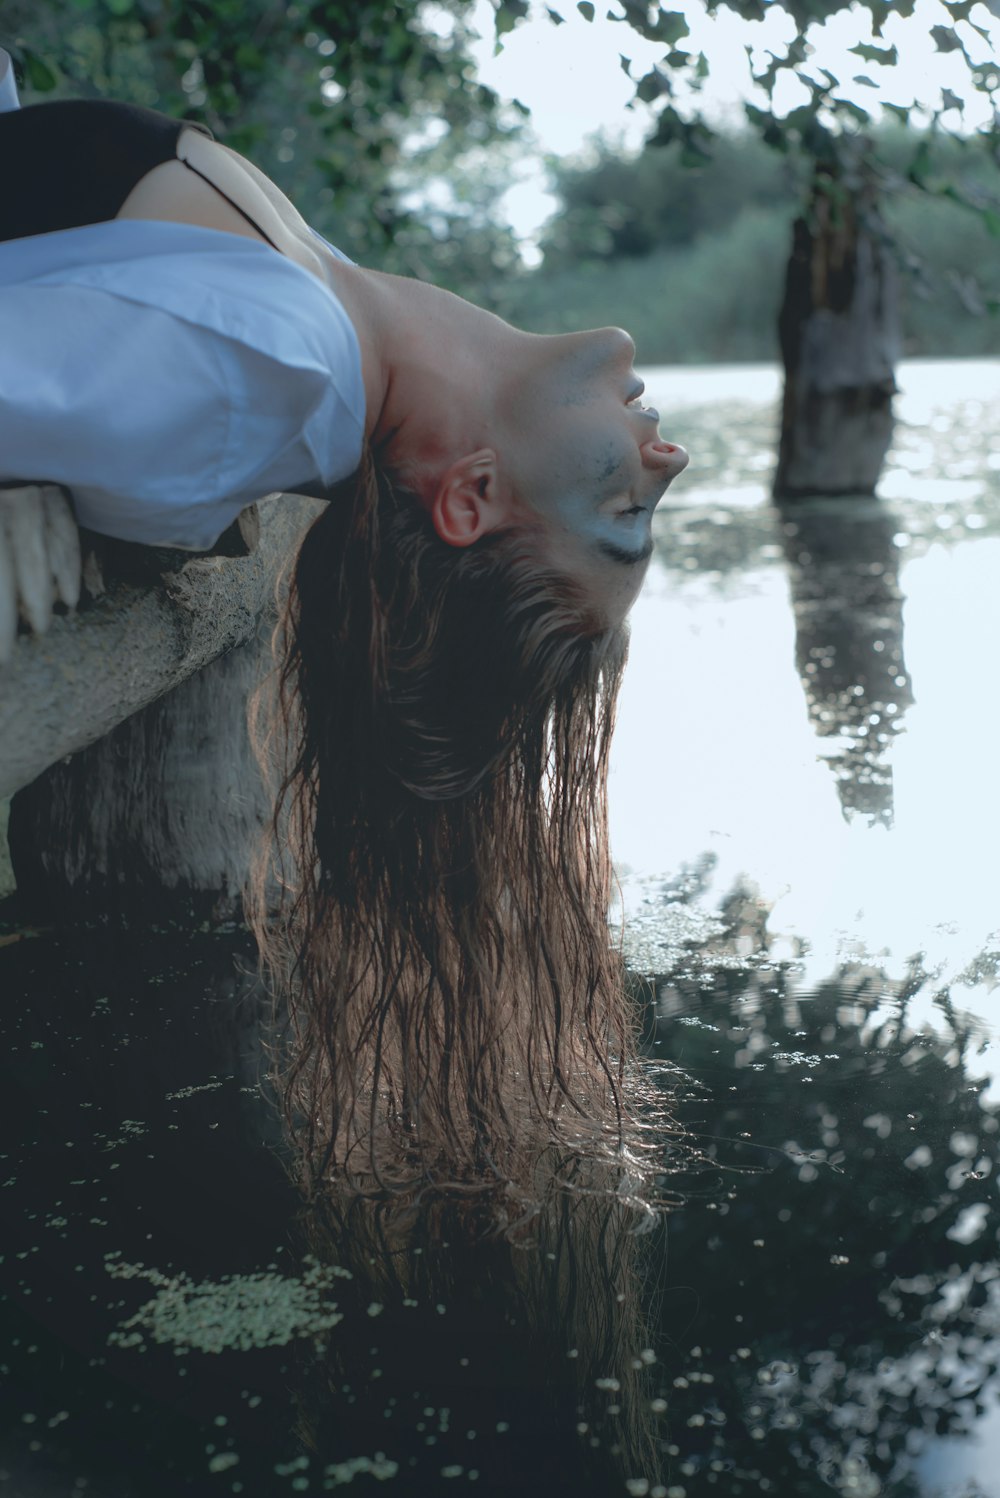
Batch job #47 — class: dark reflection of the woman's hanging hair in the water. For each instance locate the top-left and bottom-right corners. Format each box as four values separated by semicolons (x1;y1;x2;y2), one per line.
289;1158;669;1498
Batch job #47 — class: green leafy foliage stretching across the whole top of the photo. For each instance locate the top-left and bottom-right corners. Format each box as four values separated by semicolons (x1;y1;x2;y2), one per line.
0;0;1000;307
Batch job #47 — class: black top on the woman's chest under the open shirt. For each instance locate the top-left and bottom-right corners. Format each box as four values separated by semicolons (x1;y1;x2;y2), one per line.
0;99;211;240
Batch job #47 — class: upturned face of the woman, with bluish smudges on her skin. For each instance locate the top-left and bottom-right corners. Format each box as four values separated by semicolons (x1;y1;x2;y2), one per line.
500;328;687;623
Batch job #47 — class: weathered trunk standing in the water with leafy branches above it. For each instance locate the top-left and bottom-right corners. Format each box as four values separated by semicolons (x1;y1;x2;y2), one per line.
497;0;1000;499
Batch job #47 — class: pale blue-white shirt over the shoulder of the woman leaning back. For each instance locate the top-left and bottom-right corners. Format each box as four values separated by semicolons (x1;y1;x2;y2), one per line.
0;52;365;550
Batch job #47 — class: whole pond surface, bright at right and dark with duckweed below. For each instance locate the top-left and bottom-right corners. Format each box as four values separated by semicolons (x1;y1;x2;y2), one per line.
0;363;1000;1498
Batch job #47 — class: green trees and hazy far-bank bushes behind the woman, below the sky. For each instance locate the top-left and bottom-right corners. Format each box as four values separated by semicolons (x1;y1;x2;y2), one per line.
0;0;1000;371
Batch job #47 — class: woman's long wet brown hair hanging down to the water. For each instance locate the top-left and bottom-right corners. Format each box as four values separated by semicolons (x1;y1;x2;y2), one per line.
250;454;635;1194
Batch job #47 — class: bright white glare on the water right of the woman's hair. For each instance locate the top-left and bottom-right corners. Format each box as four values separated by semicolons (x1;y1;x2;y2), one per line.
612;361;1000;975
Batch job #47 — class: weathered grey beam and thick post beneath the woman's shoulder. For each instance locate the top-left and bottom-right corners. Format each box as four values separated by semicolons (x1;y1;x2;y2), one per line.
0;494;320;921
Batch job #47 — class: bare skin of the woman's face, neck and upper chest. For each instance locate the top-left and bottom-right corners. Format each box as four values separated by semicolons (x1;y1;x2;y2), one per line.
113;143;687;622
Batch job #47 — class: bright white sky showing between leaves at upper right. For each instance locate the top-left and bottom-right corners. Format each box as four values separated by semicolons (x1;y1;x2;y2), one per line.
446;0;1000;255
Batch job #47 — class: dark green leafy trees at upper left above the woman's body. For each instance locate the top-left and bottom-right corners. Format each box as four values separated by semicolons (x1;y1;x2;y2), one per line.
0;0;522;289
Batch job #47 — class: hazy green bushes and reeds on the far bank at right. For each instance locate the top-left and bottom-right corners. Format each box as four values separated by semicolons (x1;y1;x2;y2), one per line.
494;124;1000;363
